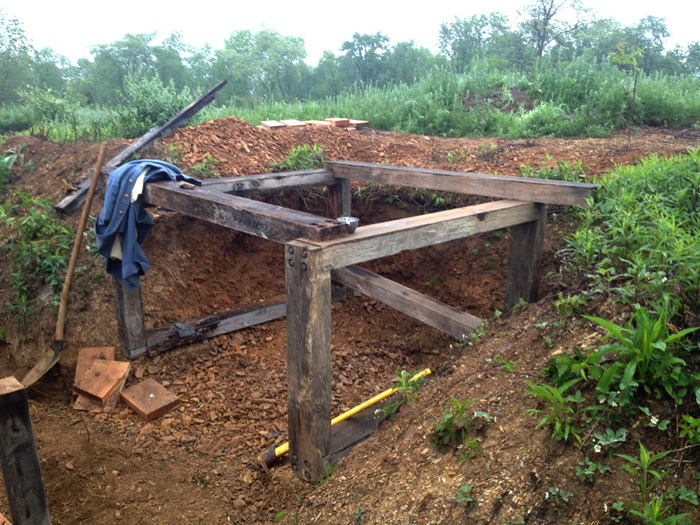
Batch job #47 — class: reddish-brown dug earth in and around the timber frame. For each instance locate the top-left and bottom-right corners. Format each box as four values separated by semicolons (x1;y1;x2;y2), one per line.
0;118;698;525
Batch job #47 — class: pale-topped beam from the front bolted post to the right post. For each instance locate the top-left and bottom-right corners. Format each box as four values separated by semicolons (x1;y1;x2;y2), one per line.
300;200;539;270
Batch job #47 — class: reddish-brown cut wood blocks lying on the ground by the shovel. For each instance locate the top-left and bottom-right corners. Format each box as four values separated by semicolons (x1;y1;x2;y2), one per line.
71;346;180;420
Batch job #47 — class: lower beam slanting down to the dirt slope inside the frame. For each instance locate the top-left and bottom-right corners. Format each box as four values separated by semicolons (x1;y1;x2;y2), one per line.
331;266;482;340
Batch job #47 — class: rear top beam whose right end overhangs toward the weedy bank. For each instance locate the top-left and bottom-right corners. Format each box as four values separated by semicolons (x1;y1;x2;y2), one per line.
326;161;597;207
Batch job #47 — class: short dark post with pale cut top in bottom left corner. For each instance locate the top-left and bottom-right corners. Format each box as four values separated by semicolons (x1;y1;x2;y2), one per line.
0;377;51;525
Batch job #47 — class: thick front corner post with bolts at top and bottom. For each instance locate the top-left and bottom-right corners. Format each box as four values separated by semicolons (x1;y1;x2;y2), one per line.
285;241;331;481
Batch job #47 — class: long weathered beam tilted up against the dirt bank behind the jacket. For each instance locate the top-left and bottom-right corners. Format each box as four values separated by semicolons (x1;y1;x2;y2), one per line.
54;80;228;214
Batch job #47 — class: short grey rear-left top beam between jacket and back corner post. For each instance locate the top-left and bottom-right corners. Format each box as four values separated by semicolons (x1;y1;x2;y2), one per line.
202;169;335;197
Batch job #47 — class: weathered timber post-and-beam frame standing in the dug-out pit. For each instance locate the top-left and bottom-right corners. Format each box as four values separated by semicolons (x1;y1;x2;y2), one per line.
106;161;596;481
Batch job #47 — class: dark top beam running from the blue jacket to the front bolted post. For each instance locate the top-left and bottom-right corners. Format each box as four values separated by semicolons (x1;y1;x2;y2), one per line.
142;182;347;243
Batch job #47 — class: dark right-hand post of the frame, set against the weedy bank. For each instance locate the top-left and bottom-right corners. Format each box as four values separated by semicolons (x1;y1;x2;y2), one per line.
505;203;547;308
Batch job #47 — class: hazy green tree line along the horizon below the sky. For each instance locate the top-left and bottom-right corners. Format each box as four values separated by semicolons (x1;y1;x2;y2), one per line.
0;0;700;107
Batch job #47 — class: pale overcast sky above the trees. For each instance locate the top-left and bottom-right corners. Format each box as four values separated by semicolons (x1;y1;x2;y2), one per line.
0;0;700;65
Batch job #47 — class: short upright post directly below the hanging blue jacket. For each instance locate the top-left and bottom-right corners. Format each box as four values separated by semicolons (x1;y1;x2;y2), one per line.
112;277;147;359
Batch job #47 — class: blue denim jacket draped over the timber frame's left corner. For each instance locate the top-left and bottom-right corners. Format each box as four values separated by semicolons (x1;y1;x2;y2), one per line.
95;160;202;290
